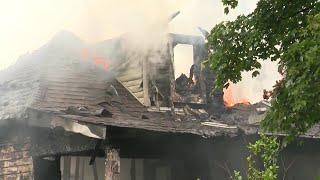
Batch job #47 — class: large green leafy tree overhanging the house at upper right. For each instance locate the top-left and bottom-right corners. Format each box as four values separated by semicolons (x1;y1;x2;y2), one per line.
207;0;320;137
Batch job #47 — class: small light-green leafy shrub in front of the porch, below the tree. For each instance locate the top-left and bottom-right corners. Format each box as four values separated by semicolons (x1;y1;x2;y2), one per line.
233;135;280;180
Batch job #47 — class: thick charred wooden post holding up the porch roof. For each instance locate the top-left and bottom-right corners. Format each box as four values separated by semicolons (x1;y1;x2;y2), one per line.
105;148;120;180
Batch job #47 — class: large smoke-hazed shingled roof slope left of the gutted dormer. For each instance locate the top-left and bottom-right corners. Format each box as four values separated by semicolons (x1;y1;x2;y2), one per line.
0;32;146;120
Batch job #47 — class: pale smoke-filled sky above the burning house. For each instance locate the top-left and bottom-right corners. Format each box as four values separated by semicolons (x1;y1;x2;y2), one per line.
0;0;280;102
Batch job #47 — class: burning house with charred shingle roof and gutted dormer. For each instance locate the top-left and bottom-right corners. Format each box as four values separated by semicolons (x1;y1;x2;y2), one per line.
0;29;320;180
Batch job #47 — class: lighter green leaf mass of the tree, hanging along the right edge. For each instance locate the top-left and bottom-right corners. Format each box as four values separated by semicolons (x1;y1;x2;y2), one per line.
263;14;320;139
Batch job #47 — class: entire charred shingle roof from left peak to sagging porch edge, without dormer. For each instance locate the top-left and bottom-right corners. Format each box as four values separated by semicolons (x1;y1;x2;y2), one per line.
0;32;320;139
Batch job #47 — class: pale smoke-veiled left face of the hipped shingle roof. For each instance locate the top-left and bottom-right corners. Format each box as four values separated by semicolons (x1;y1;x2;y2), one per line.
0;32;87;120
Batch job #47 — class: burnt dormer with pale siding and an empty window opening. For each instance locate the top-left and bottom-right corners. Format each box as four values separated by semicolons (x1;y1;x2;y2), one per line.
113;33;223;107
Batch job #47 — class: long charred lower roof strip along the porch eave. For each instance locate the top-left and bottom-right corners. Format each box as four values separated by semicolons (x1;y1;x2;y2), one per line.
29;109;239;138
